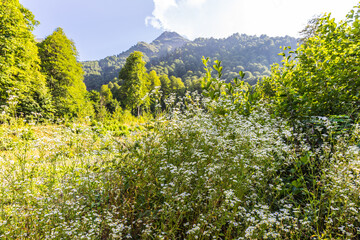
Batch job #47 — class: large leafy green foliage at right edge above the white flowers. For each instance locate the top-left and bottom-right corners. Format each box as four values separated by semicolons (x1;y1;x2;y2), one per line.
261;7;360;119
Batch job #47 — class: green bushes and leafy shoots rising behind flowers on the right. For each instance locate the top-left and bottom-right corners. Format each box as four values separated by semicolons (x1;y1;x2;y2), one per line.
202;5;360;123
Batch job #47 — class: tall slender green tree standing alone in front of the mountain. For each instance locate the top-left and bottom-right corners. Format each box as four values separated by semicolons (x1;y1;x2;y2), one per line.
119;51;146;115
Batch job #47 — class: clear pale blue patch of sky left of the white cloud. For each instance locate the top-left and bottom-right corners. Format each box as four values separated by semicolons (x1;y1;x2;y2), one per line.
20;0;163;60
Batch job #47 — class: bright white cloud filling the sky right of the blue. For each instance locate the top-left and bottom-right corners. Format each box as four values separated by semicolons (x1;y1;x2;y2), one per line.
146;0;358;39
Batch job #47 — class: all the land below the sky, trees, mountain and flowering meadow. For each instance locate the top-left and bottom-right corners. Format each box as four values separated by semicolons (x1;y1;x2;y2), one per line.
0;0;360;240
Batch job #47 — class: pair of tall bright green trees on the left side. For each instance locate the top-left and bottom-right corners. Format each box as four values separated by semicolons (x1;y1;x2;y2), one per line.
0;0;93;120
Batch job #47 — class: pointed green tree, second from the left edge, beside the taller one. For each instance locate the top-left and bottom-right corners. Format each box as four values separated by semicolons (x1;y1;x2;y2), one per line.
39;28;92;117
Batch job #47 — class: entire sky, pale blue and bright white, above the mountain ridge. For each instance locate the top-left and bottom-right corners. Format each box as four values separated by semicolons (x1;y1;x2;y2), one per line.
20;0;359;61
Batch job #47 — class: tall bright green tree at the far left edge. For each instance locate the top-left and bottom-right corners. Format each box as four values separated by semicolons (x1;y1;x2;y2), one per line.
0;0;52;117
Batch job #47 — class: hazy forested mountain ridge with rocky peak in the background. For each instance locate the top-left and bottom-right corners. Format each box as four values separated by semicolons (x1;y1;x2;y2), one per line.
83;32;298;90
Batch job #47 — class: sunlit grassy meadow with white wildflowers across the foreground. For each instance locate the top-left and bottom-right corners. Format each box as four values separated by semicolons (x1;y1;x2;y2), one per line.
0;97;360;239
